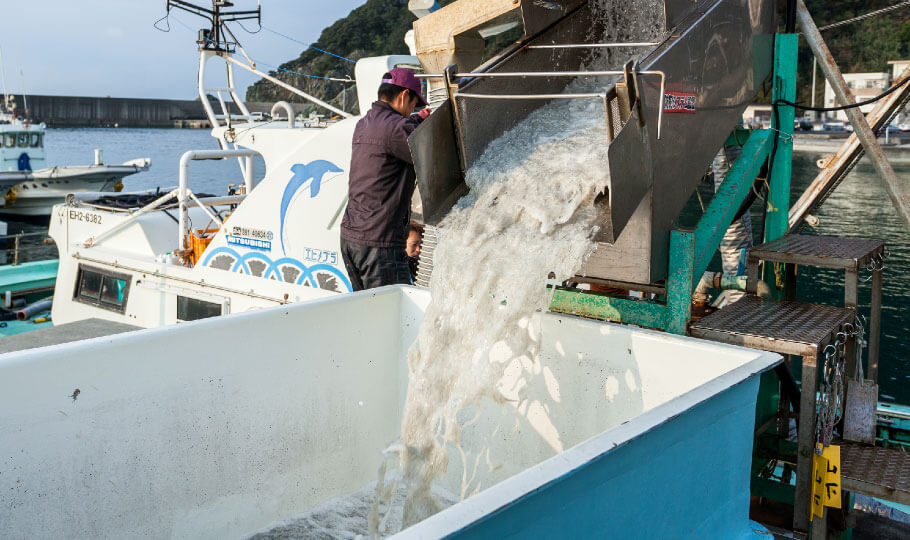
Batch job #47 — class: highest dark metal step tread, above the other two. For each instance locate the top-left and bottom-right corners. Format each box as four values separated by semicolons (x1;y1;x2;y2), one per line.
749;234;884;269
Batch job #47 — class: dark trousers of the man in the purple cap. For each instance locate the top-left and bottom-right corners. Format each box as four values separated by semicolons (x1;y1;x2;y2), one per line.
341;238;411;291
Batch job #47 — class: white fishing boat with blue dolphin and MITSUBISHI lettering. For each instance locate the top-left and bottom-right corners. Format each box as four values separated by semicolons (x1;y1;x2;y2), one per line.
49;23;420;328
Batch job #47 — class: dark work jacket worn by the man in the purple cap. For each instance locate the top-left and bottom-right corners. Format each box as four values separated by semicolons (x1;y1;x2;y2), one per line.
341;101;420;248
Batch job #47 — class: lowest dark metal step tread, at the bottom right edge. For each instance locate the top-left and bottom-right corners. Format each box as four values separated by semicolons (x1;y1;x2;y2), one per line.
840;444;910;504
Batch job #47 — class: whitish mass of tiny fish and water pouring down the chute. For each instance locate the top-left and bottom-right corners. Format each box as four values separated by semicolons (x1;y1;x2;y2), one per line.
370;0;657;536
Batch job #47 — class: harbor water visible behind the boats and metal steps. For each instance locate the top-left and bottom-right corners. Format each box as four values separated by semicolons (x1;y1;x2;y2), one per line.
10;128;910;403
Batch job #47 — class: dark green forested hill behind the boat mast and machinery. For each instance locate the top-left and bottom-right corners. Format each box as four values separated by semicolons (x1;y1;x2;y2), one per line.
246;0;910;112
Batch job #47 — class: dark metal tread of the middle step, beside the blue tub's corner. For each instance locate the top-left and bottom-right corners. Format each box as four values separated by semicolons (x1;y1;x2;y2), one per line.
689;295;856;361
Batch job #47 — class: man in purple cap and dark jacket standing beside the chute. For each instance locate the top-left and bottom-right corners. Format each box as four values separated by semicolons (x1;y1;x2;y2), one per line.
341;68;429;291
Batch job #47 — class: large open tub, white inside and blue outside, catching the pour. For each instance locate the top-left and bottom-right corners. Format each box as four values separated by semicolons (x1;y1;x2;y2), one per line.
0;286;779;539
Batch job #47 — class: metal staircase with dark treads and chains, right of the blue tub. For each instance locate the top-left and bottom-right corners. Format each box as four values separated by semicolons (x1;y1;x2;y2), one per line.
689;235;910;538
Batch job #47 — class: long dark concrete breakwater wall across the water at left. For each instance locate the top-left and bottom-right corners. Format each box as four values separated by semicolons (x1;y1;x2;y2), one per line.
4;94;272;128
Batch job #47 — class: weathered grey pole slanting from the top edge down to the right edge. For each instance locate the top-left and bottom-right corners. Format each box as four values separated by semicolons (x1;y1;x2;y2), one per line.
800;0;910;227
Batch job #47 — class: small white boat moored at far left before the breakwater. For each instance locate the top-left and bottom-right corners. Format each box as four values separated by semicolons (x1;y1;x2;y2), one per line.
0;96;152;220
